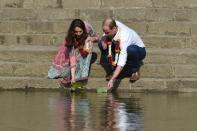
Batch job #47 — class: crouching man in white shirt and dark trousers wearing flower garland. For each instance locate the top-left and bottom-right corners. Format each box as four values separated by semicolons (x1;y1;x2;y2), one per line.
99;18;146;90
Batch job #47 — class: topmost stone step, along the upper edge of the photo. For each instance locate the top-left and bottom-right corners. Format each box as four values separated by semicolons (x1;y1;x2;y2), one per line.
1;0;197;9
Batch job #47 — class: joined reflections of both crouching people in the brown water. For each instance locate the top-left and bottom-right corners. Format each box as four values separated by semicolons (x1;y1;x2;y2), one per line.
49;91;143;131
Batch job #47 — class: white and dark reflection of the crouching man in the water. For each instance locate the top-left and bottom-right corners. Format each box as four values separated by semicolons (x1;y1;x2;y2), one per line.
104;94;142;131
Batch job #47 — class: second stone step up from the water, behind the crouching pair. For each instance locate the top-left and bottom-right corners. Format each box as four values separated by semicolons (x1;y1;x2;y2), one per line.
0;62;197;78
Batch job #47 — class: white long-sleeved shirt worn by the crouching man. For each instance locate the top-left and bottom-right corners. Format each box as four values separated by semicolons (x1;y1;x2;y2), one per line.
113;21;145;67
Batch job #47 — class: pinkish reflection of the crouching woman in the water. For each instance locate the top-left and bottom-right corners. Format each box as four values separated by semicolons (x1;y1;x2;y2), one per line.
52;94;89;131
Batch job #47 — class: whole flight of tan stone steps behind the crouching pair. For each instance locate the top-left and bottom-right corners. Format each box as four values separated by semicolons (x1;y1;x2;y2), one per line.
0;0;197;91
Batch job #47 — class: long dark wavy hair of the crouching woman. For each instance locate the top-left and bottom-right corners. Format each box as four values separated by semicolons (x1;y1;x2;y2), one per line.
65;19;88;49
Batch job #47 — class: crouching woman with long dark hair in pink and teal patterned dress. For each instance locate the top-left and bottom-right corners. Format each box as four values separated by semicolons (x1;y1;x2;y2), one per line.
48;19;98;84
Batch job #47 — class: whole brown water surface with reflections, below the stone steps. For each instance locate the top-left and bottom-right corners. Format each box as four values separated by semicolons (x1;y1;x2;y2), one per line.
0;91;197;131
